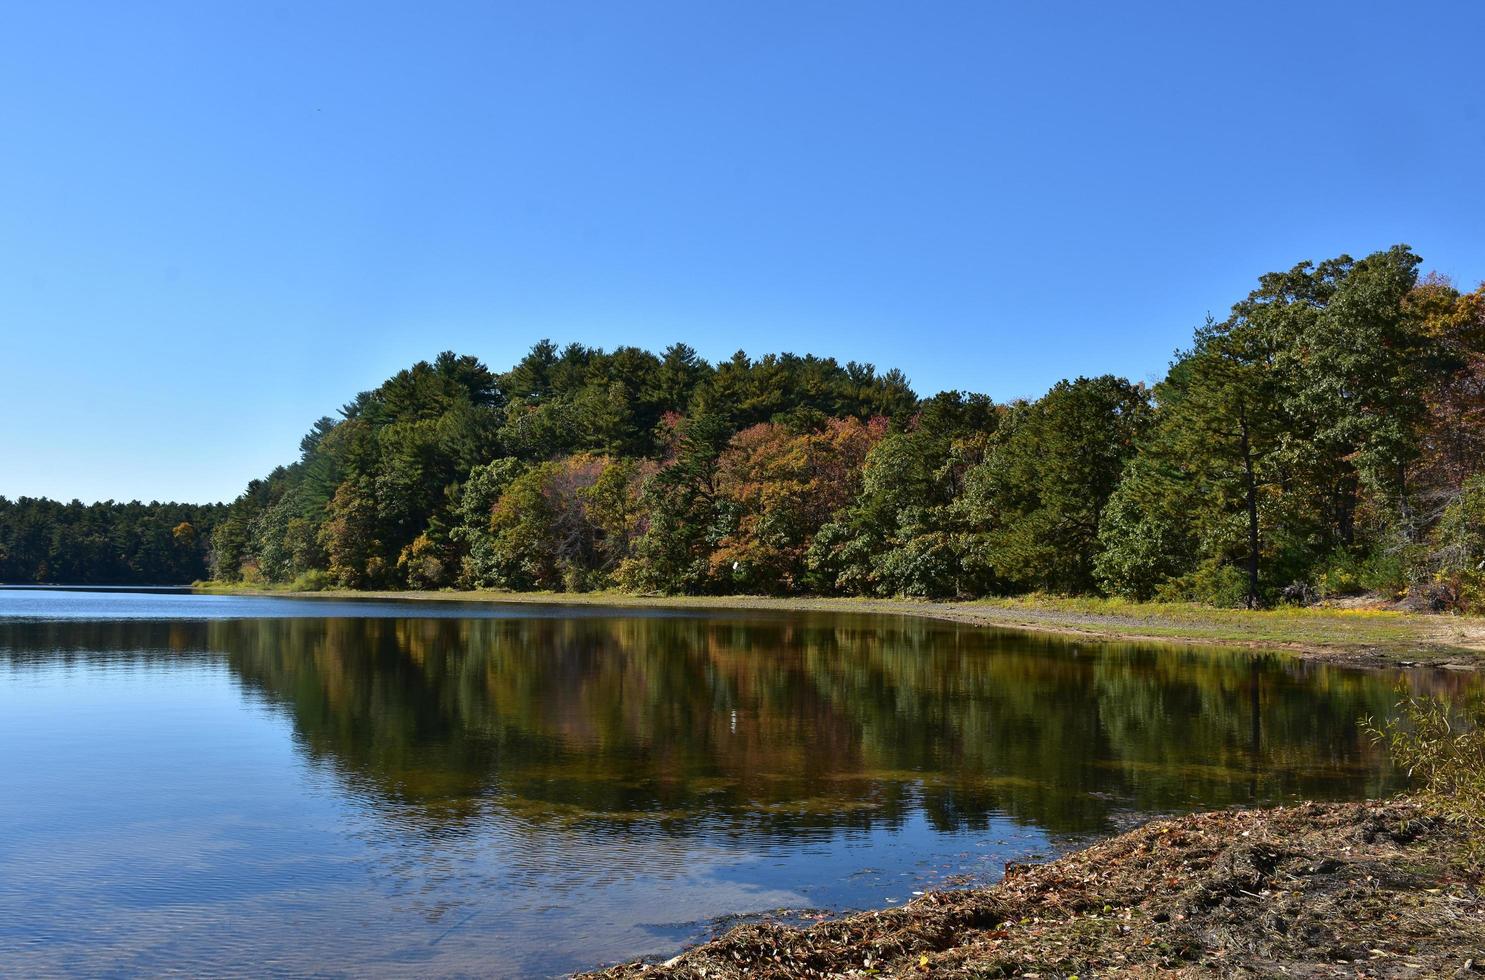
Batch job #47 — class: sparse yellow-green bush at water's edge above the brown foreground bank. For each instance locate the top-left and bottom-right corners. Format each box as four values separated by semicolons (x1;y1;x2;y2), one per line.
1362;690;1485;863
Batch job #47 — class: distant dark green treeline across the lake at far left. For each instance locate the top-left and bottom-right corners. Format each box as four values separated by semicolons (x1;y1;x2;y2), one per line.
0;497;227;585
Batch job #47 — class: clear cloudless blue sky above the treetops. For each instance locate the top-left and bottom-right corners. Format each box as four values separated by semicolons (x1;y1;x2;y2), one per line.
0;0;1485;500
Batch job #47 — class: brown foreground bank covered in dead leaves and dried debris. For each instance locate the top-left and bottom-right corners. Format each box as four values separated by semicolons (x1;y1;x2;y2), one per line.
576;800;1485;980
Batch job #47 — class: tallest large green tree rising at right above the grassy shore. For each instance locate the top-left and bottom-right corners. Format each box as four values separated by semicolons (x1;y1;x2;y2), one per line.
1099;245;1439;606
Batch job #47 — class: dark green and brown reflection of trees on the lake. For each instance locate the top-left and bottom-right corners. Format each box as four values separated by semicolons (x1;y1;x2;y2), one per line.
0;618;1466;833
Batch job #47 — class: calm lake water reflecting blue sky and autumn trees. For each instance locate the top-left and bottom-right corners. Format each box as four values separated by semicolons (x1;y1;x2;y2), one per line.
0;589;1470;976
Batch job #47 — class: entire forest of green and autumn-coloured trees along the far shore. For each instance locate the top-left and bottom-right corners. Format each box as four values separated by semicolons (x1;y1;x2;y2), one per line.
0;245;1485;610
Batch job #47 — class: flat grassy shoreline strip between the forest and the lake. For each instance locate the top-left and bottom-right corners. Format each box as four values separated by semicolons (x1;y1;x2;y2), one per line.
199;582;1485;668
